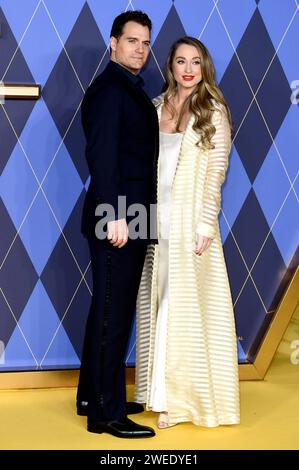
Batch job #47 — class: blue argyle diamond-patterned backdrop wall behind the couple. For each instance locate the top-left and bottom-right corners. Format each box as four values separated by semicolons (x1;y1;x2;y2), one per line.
0;0;299;371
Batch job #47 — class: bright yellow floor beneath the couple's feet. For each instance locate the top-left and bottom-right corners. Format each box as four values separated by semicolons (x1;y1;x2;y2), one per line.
0;309;299;450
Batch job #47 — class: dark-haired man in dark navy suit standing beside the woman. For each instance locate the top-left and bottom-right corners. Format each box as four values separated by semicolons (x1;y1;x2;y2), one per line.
77;11;159;438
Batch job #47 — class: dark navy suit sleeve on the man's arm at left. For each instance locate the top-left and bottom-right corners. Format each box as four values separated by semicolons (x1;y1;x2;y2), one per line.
82;87;122;219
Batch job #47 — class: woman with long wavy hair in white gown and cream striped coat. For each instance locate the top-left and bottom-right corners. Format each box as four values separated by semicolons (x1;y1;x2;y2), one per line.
135;37;239;428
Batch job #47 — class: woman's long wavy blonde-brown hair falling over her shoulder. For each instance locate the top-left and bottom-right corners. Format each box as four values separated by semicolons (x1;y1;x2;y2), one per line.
163;36;232;149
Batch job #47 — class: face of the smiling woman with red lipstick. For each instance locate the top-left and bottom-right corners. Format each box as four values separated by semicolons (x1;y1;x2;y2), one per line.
172;44;202;89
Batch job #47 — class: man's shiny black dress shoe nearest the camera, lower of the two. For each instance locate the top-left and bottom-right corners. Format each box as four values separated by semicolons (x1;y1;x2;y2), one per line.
87;418;155;439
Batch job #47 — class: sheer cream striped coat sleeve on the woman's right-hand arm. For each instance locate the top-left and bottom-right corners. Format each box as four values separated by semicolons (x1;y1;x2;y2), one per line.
196;106;231;238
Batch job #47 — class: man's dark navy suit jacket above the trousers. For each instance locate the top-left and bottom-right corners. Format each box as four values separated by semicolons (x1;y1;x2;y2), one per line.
81;61;159;239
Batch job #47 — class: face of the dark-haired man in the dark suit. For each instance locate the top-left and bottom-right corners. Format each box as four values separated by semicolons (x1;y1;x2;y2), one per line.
110;21;150;74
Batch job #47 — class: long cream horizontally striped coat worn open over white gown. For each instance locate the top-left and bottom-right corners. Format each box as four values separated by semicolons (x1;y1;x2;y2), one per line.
135;95;239;427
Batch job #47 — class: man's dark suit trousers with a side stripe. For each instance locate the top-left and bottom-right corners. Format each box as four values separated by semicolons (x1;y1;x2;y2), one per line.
77;237;146;421
